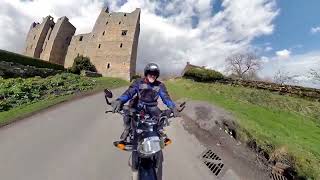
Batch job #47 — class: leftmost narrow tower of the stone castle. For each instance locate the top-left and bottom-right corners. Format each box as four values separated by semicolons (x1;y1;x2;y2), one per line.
23;16;54;58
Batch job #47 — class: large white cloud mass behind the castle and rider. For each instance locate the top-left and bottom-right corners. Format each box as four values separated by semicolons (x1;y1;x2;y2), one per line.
0;0;278;73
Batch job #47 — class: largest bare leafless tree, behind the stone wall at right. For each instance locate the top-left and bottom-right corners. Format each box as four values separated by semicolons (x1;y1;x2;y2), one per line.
226;53;261;79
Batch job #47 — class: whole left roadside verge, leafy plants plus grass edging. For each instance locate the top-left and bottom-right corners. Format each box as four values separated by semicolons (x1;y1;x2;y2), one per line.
0;73;128;126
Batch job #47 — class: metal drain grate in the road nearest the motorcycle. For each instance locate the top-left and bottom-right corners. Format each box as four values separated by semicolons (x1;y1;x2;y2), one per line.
201;149;224;176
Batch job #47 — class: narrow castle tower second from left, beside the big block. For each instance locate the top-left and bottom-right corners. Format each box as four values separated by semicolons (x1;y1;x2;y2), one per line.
40;16;76;65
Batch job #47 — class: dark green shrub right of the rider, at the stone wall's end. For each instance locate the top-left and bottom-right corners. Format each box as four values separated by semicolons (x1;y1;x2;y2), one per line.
183;67;224;82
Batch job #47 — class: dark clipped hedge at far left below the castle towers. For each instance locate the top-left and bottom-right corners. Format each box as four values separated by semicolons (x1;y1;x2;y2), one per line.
0;50;64;70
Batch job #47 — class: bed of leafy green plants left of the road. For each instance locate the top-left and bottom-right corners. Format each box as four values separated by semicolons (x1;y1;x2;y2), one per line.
0;73;97;112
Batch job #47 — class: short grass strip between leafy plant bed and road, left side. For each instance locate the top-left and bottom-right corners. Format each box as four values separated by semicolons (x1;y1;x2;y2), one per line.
0;77;128;127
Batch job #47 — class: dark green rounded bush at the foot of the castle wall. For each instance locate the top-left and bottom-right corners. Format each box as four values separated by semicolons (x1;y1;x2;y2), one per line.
70;55;97;74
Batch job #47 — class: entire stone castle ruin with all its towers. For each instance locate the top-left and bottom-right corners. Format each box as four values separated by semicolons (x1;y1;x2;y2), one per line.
24;8;141;80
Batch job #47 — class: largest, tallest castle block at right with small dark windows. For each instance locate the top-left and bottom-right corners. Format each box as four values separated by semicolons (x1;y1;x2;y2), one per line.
65;8;141;80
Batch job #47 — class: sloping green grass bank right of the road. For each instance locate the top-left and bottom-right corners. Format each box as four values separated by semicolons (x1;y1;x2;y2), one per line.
167;79;320;179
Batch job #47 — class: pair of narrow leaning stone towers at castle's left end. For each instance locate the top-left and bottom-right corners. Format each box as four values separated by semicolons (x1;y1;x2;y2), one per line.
24;16;76;65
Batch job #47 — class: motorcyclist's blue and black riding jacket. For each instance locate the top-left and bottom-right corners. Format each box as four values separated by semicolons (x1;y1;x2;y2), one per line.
117;78;176;109
